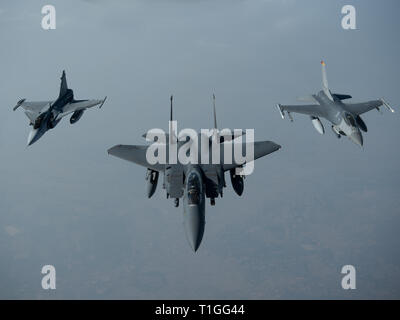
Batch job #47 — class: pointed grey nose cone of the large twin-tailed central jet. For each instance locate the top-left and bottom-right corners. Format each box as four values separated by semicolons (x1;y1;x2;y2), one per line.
184;206;205;252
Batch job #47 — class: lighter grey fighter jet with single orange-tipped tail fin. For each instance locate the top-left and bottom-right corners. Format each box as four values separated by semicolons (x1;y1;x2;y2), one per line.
277;61;394;147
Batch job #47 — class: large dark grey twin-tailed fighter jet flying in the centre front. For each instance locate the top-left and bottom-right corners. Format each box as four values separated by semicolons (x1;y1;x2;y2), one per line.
108;96;281;252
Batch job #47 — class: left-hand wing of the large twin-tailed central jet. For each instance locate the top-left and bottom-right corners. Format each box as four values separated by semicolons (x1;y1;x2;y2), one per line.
107;144;165;171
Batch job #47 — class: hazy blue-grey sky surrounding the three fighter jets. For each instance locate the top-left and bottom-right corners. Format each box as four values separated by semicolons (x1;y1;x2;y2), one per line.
0;0;400;299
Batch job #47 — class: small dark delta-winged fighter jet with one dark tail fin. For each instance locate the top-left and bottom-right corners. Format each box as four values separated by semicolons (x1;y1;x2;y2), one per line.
13;71;107;146
